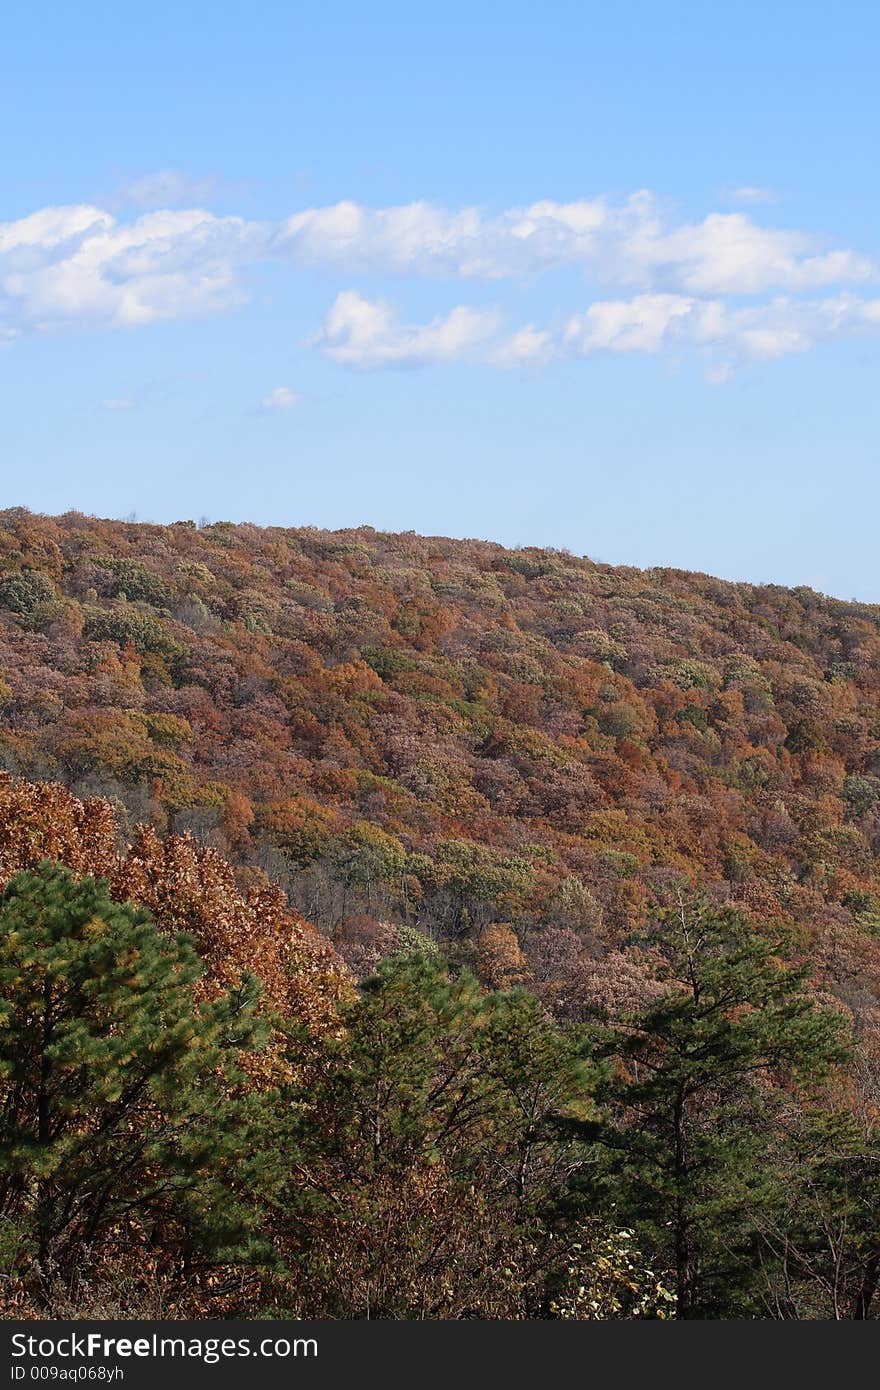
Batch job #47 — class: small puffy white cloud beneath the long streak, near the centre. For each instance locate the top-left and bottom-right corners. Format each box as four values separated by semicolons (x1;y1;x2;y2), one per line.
313;289;499;368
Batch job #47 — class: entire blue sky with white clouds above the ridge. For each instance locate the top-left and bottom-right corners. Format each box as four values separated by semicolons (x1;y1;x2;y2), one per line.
0;0;880;600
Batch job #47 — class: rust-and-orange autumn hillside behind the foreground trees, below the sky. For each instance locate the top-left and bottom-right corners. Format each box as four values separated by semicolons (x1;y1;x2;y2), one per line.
0;509;880;1020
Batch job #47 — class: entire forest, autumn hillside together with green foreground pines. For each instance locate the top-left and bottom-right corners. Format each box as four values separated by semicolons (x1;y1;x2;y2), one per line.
0;509;880;1318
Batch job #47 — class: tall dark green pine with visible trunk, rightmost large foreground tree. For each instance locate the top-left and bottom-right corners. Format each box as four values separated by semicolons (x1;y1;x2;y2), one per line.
586;902;845;1318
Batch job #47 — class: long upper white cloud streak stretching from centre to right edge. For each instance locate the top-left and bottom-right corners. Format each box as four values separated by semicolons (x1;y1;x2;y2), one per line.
272;193;880;295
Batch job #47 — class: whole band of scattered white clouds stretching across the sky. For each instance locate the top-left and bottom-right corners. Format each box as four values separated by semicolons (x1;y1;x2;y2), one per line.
0;189;880;380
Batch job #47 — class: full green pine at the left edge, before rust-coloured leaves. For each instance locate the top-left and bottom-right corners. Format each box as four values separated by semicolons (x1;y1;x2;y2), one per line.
0;862;264;1276
